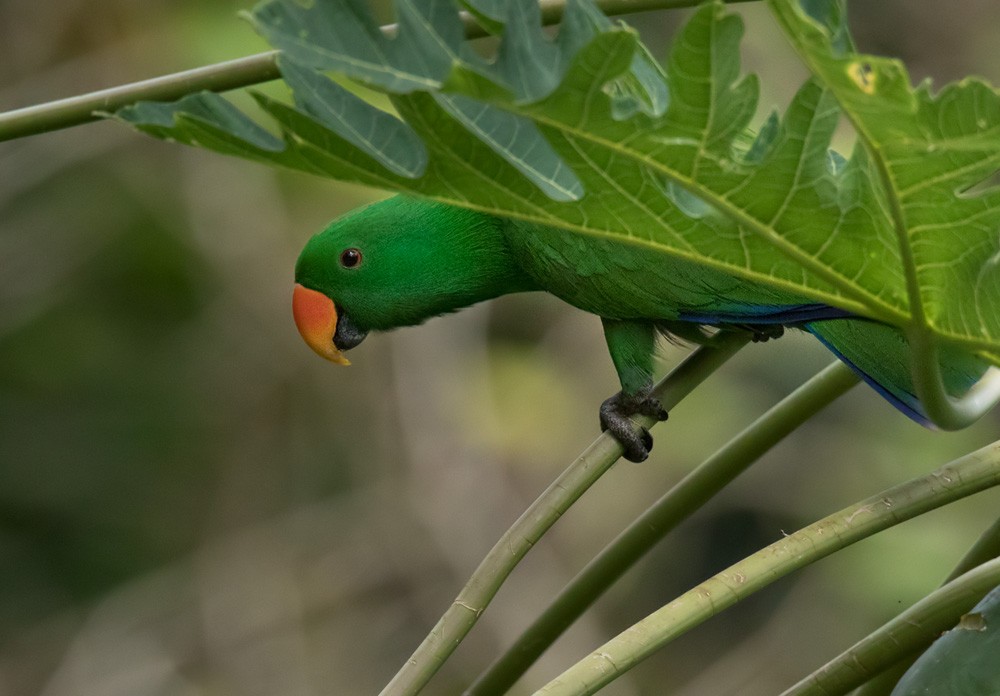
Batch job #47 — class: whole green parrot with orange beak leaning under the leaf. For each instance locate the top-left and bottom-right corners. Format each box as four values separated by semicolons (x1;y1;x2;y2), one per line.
292;196;987;462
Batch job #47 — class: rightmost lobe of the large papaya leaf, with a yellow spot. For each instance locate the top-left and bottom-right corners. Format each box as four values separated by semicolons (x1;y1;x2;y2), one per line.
769;0;1000;349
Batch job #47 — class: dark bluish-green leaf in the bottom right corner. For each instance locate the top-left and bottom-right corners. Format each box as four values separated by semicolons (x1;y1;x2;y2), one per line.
892;587;1000;696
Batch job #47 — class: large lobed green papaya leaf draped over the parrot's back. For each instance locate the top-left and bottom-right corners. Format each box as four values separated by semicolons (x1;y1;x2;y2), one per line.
118;0;1000;355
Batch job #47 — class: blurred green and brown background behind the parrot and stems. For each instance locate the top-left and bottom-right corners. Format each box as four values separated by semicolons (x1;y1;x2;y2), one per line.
0;0;1000;696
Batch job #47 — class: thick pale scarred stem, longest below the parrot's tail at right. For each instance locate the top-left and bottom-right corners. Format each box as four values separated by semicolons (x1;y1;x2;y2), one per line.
536;443;1000;696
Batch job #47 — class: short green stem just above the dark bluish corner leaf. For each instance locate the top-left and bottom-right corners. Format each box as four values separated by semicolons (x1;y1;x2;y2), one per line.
781;559;1000;696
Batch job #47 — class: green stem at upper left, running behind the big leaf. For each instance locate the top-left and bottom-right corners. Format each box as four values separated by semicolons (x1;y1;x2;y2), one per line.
0;0;747;142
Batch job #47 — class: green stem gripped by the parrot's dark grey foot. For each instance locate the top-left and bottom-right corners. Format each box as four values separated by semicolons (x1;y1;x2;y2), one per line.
382;332;749;696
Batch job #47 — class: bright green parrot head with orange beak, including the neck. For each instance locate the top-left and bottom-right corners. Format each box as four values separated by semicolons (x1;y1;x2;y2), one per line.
292;196;536;365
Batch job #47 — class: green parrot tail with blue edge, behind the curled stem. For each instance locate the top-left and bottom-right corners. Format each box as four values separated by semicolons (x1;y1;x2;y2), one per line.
801;318;989;428
